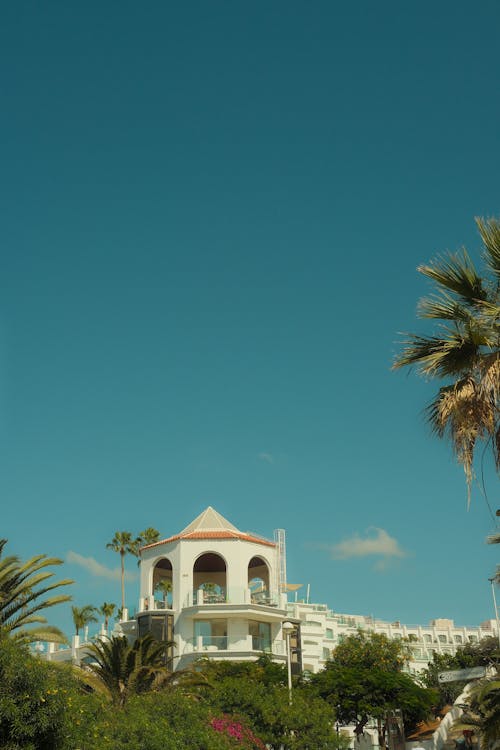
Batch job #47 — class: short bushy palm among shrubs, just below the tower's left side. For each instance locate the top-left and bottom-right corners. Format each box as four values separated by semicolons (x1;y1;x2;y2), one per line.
83;634;173;707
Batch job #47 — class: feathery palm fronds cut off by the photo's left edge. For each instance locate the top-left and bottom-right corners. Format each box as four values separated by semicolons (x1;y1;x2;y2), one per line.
0;539;73;643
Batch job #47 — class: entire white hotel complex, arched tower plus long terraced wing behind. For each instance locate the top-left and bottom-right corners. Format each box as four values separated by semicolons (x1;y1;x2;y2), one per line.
48;507;498;672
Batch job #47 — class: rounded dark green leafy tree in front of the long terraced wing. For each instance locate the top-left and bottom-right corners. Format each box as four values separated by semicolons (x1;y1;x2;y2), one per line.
311;631;436;747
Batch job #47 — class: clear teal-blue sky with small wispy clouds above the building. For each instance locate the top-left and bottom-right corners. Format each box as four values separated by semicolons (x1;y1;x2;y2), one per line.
0;0;500;632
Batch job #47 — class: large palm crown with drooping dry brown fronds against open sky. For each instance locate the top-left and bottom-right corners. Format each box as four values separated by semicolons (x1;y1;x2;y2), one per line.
393;219;500;504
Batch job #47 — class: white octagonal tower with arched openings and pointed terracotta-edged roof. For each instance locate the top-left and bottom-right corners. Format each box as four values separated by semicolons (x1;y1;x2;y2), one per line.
122;507;299;669
